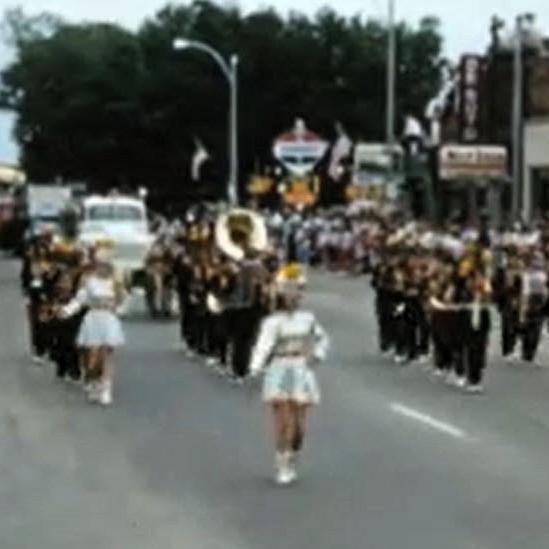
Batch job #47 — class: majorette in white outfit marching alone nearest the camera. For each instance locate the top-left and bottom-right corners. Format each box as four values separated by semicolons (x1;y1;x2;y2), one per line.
250;264;329;485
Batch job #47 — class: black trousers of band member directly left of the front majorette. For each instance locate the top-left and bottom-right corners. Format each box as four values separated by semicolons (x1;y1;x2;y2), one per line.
227;306;258;378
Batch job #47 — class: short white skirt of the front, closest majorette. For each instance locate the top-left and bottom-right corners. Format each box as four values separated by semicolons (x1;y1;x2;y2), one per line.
263;358;320;405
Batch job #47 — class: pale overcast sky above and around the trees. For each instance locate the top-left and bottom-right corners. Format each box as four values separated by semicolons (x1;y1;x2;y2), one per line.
0;0;549;161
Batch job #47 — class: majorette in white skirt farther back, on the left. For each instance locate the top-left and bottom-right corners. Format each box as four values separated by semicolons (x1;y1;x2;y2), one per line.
64;244;125;406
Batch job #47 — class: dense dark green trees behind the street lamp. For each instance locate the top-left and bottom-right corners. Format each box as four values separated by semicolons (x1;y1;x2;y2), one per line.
0;0;442;208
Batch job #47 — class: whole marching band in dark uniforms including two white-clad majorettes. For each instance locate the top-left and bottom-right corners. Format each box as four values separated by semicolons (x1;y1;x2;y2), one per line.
17;203;549;485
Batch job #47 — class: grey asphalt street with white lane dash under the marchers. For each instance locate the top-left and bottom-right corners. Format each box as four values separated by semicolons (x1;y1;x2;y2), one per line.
0;260;549;549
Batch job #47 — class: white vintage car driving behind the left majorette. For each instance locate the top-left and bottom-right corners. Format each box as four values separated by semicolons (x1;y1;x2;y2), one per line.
79;195;154;288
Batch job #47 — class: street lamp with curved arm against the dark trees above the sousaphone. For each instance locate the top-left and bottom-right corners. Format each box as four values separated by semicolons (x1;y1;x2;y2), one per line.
173;38;238;206
